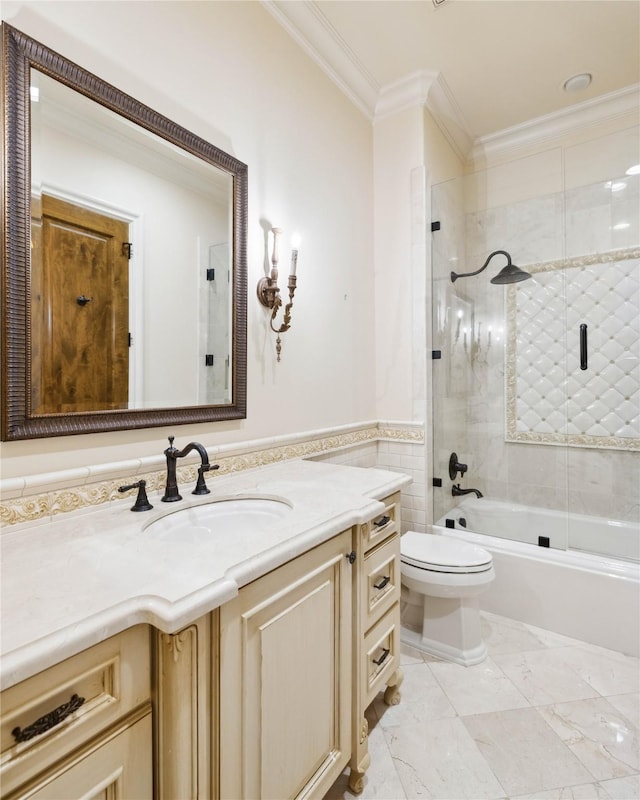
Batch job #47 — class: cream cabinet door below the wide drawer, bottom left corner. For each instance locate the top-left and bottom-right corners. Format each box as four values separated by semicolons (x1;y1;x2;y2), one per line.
7;713;153;800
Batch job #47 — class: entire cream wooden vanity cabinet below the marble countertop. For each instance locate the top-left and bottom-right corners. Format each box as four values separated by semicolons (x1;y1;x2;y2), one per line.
0;482;402;800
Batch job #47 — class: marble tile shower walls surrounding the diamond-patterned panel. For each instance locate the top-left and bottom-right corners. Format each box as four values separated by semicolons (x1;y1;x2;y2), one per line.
434;165;640;520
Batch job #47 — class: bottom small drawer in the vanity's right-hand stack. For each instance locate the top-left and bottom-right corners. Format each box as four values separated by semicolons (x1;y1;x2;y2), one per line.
360;605;400;709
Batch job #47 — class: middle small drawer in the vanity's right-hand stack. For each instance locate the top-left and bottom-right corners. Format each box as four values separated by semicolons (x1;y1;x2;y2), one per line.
360;534;400;631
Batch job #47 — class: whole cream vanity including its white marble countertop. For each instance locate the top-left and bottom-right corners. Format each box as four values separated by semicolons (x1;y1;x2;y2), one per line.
0;462;409;800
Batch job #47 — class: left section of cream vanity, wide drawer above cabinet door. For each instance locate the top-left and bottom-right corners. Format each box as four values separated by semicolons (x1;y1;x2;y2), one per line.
0;625;153;800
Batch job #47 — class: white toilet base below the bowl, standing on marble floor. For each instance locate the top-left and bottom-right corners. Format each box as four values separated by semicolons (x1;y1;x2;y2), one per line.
400;587;487;667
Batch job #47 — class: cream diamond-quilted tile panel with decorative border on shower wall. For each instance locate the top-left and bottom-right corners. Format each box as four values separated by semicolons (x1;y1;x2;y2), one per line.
507;249;640;449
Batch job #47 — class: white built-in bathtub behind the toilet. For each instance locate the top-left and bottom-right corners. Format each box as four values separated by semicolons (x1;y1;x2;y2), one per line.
433;497;640;656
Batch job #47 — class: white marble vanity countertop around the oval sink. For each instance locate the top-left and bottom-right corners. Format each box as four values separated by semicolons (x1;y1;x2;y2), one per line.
0;461;411;689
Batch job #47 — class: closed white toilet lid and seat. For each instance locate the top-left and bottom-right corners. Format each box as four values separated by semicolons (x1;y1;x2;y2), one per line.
400;531;491;573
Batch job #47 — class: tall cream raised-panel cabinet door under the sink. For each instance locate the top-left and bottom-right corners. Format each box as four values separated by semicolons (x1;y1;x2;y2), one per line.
220;531;352;800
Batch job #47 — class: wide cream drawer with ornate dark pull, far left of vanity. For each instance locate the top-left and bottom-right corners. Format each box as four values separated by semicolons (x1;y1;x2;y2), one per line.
0;625;151;791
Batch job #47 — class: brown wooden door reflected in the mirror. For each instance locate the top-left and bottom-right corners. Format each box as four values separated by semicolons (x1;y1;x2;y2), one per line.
31;195;129;415
